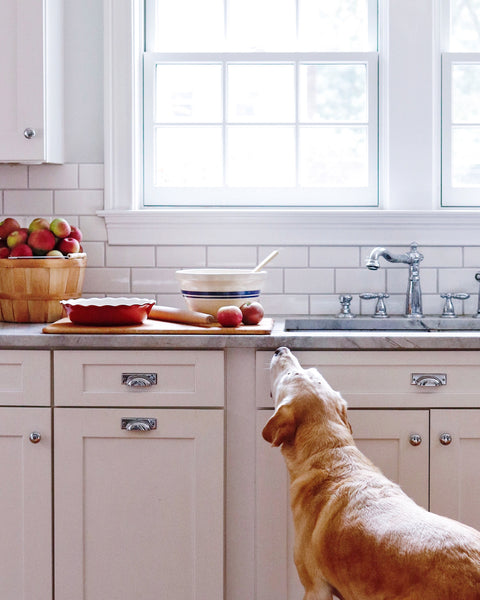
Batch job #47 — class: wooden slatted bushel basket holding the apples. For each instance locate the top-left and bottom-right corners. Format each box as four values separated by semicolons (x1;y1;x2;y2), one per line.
0;257;87;323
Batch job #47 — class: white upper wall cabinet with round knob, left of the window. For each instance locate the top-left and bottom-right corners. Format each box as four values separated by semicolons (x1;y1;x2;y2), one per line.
0;0;63;163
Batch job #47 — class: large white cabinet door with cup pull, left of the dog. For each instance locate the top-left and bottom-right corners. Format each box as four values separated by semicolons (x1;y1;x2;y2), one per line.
54;408;224;600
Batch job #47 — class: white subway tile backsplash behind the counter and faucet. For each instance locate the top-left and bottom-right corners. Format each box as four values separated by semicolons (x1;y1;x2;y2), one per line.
0;164;480;316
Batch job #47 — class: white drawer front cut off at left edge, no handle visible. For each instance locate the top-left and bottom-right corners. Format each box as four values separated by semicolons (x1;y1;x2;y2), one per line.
0;350;50;406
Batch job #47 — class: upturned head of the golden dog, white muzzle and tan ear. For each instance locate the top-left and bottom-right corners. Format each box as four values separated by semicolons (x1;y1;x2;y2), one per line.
262;347;352;446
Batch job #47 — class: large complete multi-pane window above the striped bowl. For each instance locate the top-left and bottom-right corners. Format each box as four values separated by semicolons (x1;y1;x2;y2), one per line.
143;0;378;207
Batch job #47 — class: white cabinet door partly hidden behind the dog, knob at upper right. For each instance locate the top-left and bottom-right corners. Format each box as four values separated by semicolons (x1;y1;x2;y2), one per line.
255;410;429;600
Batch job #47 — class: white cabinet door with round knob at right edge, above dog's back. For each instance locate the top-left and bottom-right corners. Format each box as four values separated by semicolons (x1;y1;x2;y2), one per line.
430;409;480;529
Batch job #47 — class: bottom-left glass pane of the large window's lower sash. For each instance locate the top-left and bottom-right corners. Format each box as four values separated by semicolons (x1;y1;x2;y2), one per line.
154;126;223;187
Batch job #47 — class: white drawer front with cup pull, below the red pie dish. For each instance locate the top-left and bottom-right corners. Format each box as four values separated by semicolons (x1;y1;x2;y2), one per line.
54;350;224;407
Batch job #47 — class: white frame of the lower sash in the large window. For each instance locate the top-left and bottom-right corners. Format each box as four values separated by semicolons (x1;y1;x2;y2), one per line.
143;52;378;208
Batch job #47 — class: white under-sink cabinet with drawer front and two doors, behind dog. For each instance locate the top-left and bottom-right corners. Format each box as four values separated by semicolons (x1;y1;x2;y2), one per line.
255;351;480;600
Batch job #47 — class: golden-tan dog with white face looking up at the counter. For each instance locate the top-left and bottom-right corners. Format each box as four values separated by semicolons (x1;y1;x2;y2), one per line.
263;348;480;600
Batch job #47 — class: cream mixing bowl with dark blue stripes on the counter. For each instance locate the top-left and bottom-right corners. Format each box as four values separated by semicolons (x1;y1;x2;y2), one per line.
175;269;267;316
